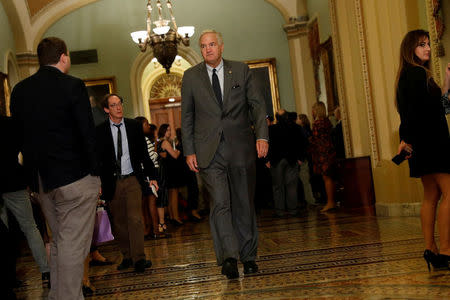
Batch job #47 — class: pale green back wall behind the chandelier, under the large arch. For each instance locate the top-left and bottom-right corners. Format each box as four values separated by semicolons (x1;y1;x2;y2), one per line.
44;0;295;117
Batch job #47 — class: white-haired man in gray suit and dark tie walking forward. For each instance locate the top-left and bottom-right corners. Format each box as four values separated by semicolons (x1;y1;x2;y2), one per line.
181;30;269;279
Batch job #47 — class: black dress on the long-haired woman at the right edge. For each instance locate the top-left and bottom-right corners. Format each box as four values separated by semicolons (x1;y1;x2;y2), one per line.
397;66;450;177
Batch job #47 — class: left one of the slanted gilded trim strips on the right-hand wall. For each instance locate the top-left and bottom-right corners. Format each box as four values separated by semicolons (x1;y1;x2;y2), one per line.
328;0;353;157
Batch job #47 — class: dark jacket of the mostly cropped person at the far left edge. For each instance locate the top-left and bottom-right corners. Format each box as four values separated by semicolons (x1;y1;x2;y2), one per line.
0;116;27;194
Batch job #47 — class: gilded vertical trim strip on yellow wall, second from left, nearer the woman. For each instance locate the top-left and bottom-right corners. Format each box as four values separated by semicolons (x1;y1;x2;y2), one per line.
354;0;380;167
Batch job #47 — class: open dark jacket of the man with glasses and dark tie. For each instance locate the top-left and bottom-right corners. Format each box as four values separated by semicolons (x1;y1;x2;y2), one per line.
96;118;156;200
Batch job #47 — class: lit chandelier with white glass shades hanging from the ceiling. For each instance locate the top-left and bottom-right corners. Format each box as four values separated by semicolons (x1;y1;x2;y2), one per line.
131;0;195;74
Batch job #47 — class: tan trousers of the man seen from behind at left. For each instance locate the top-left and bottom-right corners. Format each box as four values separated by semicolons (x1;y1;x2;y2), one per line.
39;175;100;300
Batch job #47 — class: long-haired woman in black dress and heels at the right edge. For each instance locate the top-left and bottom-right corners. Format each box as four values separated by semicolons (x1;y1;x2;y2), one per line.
396;30;450;268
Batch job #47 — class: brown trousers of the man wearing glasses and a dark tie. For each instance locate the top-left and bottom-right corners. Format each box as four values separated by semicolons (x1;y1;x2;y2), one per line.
111;176;145;263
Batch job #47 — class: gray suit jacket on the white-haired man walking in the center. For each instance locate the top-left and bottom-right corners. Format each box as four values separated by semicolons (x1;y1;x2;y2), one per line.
181;60;269;168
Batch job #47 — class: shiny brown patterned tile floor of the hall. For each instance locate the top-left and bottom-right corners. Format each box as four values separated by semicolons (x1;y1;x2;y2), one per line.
16;209;450;300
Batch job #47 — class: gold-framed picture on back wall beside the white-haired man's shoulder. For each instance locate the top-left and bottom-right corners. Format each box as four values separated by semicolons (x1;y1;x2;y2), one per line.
245;58;280;117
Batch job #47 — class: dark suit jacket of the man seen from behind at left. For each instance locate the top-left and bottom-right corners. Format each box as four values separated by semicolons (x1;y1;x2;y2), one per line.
11;66;96;191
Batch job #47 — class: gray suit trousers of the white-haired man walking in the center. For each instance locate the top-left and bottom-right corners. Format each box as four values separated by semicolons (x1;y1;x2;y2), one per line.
200;140;258;265
